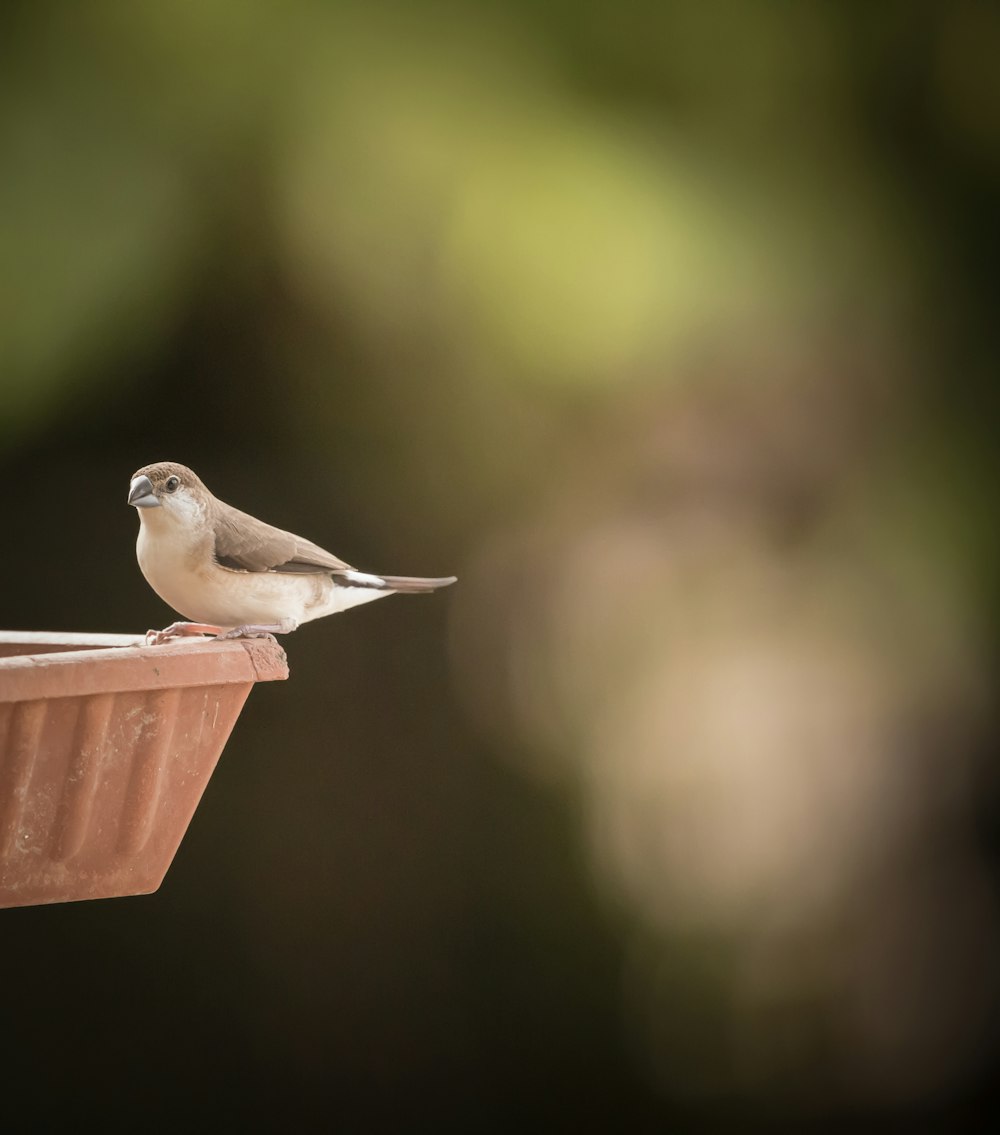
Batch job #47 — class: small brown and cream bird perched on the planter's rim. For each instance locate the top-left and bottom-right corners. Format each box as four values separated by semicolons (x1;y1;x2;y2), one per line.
128;461;456;646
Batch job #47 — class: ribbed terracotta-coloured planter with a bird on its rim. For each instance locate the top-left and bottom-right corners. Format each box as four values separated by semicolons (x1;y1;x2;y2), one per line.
0;631;288;907
